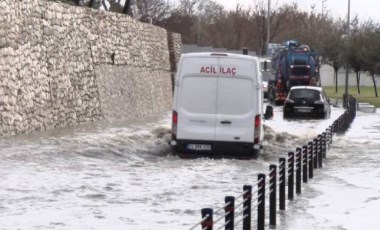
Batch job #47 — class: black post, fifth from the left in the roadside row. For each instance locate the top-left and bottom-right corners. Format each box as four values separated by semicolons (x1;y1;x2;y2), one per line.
269;165;277;226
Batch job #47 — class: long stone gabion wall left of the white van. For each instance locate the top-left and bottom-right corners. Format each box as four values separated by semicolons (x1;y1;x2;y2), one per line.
0;0;180;136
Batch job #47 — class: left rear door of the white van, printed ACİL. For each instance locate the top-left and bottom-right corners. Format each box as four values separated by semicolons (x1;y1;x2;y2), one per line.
177;57;219;142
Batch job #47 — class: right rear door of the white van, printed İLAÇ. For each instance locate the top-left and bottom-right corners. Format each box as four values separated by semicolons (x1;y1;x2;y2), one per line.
216;57;258;143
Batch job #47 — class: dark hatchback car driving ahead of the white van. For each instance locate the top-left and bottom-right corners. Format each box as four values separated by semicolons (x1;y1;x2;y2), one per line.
283;86;331;119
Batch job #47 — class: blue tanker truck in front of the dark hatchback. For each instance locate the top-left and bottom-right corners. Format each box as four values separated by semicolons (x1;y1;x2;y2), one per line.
268;40;321;105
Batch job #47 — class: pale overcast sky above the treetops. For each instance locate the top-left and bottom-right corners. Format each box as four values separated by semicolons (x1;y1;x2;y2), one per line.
220;0;380;23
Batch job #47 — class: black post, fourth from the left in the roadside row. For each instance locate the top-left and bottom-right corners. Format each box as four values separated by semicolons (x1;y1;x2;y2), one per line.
256;173;265;230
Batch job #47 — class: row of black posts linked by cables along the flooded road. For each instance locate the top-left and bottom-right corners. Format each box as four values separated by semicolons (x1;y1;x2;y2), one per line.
189;96;357;230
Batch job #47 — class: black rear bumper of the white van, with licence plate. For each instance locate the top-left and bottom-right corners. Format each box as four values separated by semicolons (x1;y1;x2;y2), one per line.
171;140;259;159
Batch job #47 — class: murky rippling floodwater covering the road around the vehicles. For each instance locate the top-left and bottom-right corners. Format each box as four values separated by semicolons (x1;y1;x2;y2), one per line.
0;107;380;230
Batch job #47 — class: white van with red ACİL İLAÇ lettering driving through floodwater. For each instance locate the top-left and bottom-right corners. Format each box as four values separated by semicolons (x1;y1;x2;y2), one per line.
170;53;273;158
